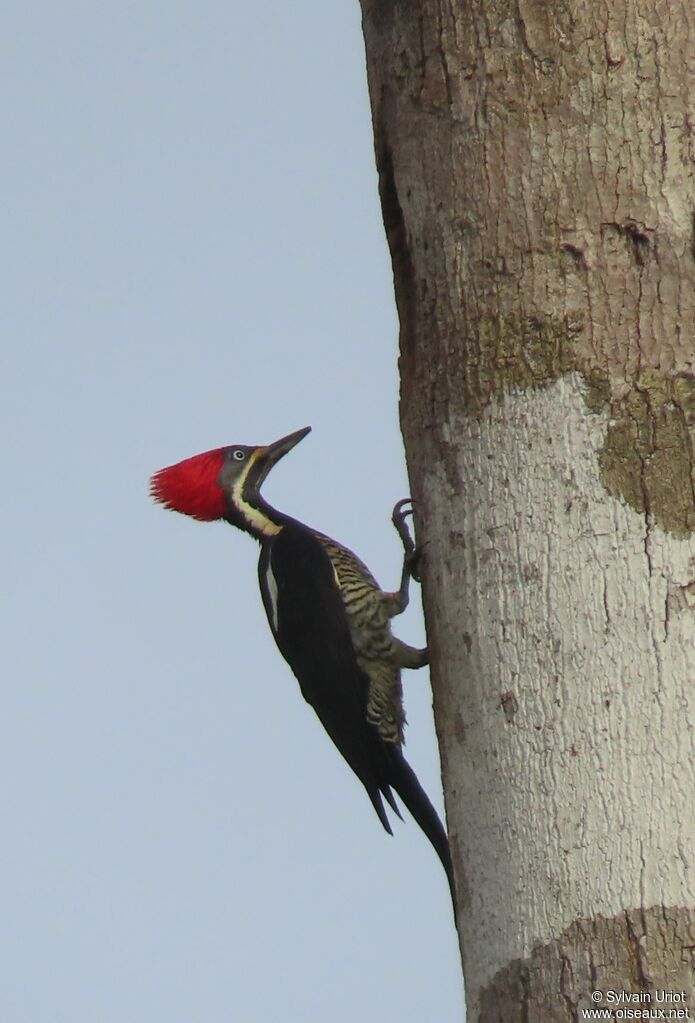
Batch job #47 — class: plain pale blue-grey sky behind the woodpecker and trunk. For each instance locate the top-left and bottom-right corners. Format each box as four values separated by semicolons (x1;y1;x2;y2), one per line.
0;0;463;1023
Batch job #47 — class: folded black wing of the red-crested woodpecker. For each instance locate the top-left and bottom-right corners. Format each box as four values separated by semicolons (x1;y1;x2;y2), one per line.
258;524;393;834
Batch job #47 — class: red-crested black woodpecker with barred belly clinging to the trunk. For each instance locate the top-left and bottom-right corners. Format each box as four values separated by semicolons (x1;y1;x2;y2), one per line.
150;427;455;911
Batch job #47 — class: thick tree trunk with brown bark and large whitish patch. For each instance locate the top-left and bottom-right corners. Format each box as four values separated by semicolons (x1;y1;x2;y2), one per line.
362;0;695;1023
